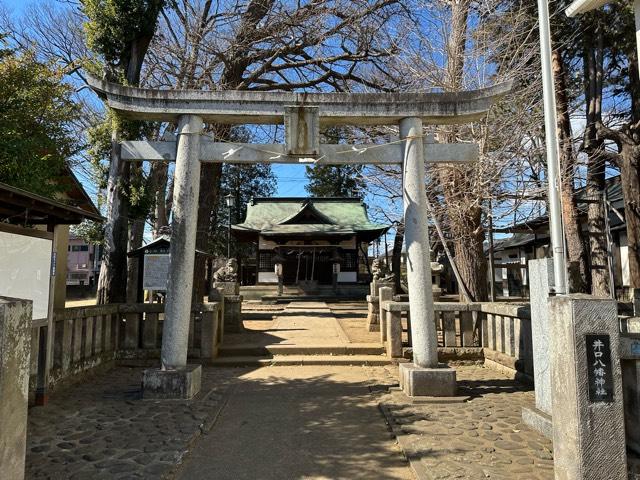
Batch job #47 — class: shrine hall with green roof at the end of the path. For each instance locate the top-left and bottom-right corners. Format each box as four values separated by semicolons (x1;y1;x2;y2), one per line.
231;197;390;285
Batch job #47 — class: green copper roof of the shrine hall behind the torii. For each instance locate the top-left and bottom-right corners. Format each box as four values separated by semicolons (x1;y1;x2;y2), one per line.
232;198;389;235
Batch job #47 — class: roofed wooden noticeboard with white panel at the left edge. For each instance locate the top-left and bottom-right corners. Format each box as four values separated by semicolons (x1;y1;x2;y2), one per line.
0;180;103;404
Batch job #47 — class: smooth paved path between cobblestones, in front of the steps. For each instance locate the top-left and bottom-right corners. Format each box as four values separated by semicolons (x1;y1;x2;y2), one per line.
177;366;413;480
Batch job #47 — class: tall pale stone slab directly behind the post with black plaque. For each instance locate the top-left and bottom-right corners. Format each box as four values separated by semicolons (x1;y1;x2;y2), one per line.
522;258;554;439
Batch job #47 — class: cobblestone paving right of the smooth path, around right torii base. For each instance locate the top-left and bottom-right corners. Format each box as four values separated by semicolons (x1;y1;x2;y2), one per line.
381;366;553;480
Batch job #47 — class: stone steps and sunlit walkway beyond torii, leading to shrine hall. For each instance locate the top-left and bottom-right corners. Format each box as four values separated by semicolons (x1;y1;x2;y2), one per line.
212;301;393;366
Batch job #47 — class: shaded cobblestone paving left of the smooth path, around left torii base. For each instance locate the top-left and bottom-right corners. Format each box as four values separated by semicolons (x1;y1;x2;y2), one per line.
26;367;244;480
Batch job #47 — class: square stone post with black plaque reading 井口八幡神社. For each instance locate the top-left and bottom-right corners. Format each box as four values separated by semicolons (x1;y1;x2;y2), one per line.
550;295;627;480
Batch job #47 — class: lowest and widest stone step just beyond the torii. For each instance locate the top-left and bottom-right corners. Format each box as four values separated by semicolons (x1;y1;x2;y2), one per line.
207;355;398;367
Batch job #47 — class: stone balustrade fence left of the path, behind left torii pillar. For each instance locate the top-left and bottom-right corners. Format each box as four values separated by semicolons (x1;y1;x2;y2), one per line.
30;302;224;397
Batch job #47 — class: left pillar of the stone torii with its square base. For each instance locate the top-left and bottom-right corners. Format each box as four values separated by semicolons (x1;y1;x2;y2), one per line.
142;115;203;398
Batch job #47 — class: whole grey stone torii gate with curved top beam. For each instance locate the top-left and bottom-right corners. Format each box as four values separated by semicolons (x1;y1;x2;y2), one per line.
89;77;512;398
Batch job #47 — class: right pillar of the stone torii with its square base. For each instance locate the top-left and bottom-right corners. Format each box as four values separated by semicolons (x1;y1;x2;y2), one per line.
400;118;456;397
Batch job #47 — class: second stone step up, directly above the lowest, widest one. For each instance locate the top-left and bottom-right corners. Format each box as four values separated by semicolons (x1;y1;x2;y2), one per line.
219;343;385;357
